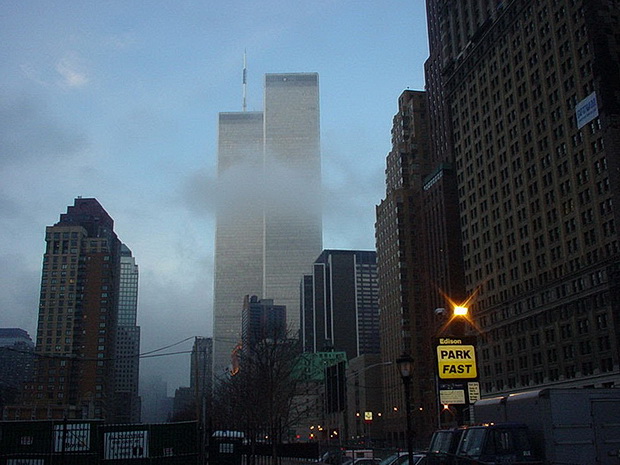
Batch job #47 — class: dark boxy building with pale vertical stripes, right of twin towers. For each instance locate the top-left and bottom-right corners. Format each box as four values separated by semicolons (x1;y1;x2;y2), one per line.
300;250;379;360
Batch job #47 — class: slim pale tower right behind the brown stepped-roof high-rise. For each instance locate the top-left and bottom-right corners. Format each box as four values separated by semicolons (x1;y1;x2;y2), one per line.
114;244;141;423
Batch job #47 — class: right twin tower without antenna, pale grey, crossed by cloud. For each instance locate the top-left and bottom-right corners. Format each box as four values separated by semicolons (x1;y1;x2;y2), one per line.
263;73;323;318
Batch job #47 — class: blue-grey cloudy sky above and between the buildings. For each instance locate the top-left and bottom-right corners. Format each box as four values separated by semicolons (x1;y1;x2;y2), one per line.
0;0;428;393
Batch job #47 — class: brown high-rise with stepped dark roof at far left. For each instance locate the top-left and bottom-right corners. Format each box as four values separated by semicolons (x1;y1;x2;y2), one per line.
7;197;128;421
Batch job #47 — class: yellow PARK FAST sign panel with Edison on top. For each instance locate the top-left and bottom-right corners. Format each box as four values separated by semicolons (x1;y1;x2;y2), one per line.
437;338;478;379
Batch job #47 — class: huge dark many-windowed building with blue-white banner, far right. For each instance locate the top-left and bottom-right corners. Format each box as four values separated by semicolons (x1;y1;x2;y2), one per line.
426;0;620;395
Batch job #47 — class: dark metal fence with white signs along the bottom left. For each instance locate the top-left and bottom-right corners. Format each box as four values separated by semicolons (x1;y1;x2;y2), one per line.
0;420;319;465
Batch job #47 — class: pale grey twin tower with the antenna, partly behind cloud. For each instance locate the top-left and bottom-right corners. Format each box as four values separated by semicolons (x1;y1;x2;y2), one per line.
213;112;263;379
